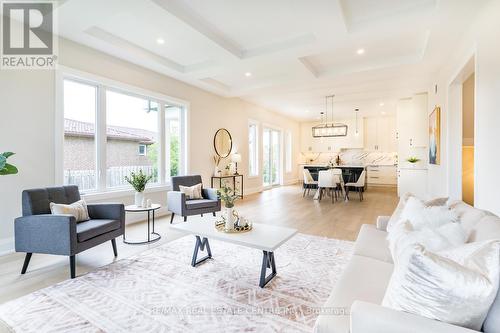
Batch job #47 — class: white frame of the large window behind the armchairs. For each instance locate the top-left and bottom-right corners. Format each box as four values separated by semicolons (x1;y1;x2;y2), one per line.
55;65;190;199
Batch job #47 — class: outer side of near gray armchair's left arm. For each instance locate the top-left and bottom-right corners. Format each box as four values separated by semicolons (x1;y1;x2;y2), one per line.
14;214;77;255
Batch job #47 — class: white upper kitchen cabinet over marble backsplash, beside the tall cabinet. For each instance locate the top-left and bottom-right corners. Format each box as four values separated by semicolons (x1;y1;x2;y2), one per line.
364;117;397;152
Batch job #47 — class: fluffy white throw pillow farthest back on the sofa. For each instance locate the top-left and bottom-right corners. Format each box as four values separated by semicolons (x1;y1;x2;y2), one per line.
398;197;458;230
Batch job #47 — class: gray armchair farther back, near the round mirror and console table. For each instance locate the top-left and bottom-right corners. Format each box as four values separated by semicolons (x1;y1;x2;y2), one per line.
167;175;221;223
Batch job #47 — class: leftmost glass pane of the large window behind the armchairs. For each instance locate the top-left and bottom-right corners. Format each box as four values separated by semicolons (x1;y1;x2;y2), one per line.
63;80;97;191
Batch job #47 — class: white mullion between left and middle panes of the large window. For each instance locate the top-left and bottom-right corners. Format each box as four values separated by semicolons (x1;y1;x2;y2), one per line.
96;85;107;191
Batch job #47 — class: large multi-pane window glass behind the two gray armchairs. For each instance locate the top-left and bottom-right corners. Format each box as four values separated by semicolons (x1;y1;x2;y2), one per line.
63;78;186;192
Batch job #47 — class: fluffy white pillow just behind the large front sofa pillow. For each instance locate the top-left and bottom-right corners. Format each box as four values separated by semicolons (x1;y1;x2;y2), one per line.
387;221;468;262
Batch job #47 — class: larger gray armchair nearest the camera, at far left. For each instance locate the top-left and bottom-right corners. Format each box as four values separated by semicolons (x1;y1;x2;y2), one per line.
14;186;125;279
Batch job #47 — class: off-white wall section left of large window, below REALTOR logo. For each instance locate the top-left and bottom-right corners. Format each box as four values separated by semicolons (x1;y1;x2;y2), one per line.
0;70;55;253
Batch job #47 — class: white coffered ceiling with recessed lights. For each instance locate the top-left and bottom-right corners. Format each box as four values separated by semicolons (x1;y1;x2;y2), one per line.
54;0;488;120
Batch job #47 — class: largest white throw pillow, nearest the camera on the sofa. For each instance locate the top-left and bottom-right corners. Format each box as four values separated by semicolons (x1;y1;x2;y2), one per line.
382;240;500;330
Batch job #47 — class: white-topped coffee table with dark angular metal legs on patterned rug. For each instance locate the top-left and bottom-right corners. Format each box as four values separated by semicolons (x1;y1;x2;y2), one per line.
170;221;297;288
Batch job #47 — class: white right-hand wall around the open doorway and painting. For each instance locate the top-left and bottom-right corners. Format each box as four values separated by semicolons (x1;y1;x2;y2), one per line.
429;1;500;214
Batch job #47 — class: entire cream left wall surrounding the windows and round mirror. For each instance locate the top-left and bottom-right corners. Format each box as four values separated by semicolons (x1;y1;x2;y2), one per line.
0;39;300;253
